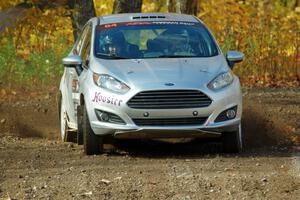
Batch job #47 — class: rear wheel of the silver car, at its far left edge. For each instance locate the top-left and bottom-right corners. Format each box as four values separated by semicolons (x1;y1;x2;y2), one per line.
57;94;76;142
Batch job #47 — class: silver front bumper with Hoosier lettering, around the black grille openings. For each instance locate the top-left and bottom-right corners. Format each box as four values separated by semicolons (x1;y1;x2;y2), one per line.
85;78;242;138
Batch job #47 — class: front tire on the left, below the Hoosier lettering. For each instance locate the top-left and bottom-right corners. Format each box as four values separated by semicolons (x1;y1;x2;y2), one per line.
82;106;103;155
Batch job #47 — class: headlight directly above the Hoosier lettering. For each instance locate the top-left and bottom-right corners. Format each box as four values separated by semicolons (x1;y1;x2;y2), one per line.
93;73;130;94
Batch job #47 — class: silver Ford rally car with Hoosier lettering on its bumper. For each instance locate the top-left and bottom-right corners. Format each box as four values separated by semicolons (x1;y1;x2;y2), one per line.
59;13;244;155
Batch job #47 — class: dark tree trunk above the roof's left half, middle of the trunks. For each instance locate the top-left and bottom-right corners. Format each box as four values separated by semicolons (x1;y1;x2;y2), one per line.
113;0;142;14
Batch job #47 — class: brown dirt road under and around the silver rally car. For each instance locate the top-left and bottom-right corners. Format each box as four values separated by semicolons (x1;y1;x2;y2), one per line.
0;89;300;199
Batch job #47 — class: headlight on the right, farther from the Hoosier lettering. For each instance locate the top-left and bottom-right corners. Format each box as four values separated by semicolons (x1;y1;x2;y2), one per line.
207;71;234;90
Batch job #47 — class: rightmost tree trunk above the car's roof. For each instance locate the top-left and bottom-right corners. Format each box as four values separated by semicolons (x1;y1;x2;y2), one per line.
176;0;199;16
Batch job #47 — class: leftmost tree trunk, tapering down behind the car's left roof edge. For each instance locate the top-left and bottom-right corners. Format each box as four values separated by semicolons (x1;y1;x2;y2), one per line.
68;0;96;40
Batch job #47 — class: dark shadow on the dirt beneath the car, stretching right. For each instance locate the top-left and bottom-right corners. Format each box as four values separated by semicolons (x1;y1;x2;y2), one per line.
107;139;299;159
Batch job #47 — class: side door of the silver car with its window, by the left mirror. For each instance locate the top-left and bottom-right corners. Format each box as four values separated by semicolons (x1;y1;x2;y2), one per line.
63;25;90;129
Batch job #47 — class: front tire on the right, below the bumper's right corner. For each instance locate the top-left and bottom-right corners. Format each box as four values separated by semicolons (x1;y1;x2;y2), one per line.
221;124;244;153
